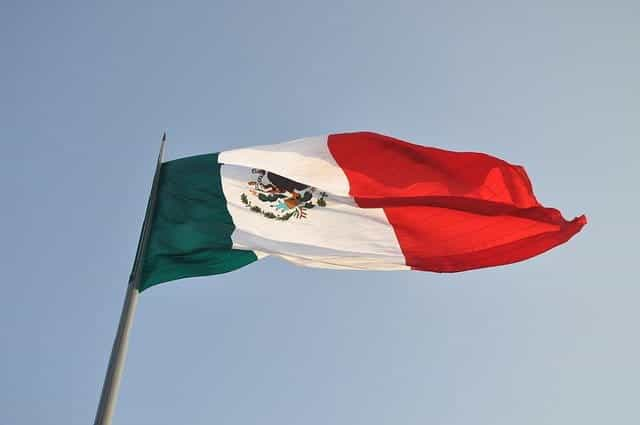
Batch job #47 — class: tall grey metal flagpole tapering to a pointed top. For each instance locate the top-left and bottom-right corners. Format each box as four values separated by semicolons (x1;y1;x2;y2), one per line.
94;133;167;425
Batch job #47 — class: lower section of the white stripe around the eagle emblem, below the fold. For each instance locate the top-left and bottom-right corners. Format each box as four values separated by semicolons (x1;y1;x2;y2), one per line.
221;164;409;270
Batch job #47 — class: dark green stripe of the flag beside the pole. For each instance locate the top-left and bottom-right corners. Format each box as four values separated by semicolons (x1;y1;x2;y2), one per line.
138;154;257;291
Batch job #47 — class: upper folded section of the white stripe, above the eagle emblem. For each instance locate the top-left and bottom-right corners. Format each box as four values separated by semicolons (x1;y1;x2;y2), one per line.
218;136;349;196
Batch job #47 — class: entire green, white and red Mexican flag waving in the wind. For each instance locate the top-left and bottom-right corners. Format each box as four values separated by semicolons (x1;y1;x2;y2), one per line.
139;132;586;290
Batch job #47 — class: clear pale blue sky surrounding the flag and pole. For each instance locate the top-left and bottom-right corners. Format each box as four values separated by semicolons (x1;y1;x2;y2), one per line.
0;0;640;425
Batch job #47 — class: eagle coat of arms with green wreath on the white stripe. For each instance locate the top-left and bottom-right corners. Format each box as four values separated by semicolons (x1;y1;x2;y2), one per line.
240;168;327;221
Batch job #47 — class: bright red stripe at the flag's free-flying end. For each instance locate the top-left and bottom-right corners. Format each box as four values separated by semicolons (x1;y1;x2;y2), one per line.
328;133;586;272
